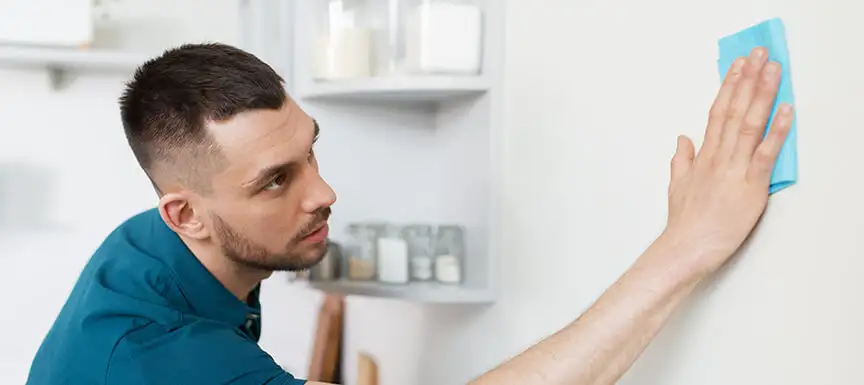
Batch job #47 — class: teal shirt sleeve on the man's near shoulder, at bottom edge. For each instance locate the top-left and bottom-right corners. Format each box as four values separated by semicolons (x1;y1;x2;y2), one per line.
105;321;306;385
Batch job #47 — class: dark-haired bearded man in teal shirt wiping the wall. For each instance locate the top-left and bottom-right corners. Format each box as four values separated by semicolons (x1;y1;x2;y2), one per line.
28;44;792;385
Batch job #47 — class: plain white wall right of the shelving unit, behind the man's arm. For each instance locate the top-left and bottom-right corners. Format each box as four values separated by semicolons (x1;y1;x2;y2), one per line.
462;0;864;385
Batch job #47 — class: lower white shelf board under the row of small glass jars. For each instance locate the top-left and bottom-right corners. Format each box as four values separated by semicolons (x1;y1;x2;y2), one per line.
309;280;495;304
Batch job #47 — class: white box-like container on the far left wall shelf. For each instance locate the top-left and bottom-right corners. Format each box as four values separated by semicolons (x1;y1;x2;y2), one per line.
0;0;94;47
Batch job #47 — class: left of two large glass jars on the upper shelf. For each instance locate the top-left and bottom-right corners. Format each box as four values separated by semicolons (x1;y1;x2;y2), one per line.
312;0;376;80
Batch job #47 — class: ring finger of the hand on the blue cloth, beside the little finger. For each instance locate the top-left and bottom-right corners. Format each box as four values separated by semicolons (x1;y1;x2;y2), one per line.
732;62;782;166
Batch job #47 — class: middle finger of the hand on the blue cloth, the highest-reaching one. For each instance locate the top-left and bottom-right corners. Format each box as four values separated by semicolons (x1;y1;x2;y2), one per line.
720;47;768;156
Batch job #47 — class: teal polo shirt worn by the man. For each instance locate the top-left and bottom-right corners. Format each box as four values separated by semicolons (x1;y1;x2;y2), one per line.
27;209;305;385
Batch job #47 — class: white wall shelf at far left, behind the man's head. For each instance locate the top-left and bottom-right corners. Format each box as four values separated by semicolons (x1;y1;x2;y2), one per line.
0;46;149;88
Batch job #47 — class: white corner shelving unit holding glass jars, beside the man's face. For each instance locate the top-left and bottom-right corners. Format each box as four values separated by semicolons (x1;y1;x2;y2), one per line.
283;0;504;305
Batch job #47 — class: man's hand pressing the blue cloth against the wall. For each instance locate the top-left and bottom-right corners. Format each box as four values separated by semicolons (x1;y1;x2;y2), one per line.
664;48;792;274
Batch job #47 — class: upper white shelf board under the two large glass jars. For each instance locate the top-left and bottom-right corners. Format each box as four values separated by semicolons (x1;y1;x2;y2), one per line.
299;76;489;103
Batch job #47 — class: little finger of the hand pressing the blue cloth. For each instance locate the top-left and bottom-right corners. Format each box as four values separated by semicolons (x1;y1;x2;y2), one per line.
747;104;794;184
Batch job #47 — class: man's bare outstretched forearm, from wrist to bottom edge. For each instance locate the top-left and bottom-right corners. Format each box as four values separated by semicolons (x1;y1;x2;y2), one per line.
472;234;700;385
